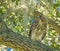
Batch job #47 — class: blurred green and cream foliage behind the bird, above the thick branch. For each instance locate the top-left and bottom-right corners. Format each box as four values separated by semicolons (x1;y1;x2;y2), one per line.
0;0;60;49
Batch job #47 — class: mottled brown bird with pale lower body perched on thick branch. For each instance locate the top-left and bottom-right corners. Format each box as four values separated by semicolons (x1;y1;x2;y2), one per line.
29;11;47;42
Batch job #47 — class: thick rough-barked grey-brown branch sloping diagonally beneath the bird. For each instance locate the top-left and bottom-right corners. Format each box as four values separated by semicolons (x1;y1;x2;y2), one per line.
0;21;59;51
